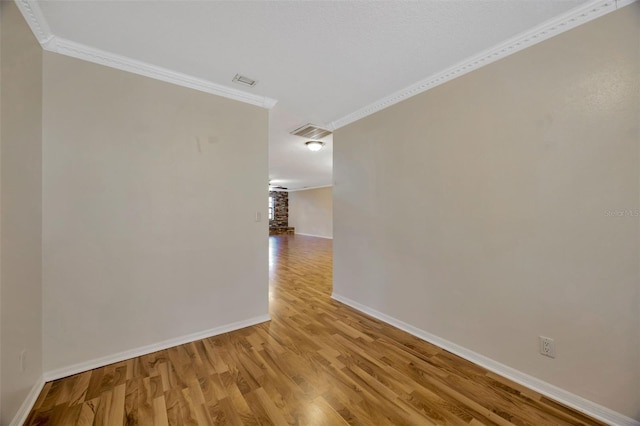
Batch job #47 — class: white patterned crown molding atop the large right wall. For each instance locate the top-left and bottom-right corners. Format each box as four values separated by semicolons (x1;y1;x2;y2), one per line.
328;0;637;131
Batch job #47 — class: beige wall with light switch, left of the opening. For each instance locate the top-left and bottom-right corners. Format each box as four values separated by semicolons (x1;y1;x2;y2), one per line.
43;53;268;371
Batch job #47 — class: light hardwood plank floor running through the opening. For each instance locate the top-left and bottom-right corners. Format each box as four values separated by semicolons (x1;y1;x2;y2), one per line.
27;236;601;426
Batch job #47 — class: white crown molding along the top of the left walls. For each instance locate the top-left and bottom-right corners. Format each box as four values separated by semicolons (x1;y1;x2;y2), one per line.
15;0;278;109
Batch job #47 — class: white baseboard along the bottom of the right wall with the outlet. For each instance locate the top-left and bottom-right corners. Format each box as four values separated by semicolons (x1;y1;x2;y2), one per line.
331;293;640;426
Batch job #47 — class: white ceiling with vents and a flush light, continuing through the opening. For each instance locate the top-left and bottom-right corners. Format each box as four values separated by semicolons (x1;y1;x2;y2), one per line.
19;0;597;189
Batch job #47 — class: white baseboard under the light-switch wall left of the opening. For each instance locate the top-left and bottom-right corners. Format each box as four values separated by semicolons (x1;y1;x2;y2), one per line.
44;315;271;382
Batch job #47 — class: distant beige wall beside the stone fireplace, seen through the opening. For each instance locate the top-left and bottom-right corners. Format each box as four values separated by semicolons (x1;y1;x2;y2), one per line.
289;187;333;238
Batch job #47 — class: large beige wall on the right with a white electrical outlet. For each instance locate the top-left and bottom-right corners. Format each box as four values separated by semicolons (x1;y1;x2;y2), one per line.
333;4;640;420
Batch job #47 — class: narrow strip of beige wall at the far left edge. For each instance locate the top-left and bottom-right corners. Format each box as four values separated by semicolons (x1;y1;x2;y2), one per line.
0;1;42;424
